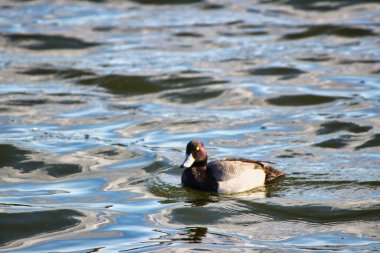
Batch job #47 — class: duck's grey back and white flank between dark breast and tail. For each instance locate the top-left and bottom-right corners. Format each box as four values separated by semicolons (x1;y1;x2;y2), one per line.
208;160;266;194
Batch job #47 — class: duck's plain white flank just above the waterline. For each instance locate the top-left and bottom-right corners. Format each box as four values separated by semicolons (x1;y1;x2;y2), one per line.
218;166;266;194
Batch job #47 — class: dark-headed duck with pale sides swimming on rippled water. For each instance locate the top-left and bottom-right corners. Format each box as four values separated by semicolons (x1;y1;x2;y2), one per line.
180;140;285;194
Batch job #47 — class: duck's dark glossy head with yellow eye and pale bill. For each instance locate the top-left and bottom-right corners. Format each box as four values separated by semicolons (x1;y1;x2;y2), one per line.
181;140;207;168
